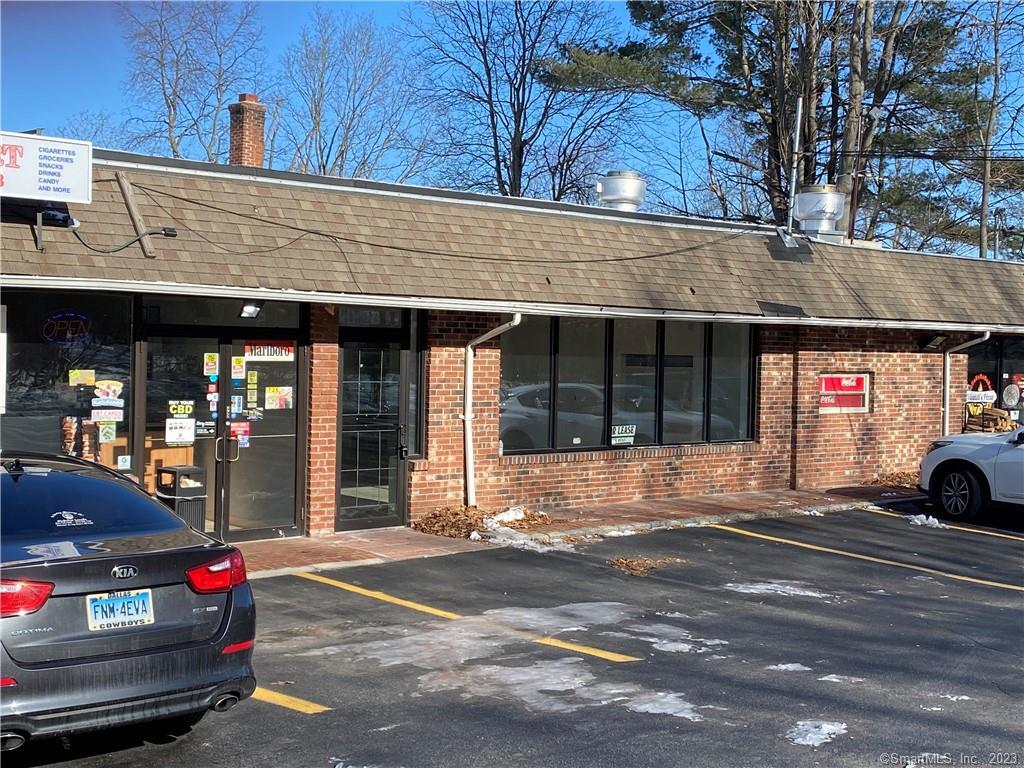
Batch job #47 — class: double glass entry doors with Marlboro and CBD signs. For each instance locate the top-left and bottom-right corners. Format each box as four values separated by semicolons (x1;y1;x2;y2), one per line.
141;335;299;540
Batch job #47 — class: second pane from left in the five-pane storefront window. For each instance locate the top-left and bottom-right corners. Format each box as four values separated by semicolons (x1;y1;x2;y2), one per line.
557;317;605;447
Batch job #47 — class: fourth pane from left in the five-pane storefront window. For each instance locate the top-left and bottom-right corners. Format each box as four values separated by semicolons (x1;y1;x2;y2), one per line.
662;323;706;443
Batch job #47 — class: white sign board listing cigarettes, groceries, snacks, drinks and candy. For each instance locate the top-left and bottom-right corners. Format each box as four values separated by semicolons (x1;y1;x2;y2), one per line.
0;131;92;204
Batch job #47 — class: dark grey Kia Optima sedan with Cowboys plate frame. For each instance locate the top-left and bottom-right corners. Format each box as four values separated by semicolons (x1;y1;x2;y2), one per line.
0;452;256;751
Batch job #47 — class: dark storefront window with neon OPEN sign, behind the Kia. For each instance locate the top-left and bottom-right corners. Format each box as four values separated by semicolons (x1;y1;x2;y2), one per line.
0;291;132;469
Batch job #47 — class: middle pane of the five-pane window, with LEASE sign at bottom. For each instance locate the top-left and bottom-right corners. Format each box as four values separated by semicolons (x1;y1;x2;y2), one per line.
611;319;657;445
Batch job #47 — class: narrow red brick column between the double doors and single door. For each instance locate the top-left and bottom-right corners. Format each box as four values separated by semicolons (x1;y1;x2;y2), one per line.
306;304;339;536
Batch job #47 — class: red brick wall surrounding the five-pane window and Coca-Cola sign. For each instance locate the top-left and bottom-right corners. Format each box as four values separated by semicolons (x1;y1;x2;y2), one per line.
409;312;967;519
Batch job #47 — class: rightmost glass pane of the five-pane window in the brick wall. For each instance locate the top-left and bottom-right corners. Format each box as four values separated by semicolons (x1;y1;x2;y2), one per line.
710;323;751;440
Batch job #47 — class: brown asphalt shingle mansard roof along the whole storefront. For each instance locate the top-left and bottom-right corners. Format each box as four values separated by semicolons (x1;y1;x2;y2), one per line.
0;153;1024;328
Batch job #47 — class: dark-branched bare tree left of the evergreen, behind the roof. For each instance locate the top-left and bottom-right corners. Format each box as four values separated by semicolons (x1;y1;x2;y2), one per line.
407;0;630;200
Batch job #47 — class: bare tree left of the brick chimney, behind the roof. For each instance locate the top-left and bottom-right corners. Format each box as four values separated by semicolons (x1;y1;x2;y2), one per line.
121;1;263;162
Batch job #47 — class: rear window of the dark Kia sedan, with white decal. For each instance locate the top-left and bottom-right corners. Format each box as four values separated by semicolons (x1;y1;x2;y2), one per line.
0;462;185;560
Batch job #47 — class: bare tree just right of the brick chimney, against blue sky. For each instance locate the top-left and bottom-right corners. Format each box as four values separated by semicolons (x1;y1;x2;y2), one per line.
281;8;429;181
